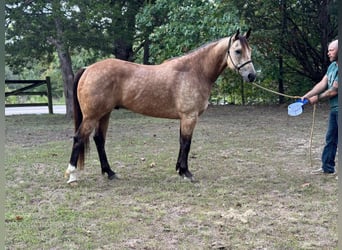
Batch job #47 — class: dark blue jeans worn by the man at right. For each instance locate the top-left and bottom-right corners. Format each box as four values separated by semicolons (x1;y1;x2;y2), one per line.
322;111;338;173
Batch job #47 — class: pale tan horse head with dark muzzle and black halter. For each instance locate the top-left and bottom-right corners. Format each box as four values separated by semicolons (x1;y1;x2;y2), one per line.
227;29;256;82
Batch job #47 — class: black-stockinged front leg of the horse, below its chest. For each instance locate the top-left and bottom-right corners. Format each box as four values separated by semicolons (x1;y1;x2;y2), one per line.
176;116;197;182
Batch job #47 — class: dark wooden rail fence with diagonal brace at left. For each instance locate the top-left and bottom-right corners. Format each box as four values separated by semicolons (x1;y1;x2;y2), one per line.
5;77;53;114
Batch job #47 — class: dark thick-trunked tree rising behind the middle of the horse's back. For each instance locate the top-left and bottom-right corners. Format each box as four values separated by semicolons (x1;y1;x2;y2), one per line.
78;0;145;61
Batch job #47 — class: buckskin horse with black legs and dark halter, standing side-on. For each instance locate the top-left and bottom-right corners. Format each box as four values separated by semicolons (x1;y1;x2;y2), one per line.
65;29;256;184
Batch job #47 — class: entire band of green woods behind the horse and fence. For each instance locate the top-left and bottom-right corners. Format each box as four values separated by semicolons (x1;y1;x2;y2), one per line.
5;0;338;116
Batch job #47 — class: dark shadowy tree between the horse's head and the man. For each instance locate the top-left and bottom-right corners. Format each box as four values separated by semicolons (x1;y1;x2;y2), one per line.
233;0;337;101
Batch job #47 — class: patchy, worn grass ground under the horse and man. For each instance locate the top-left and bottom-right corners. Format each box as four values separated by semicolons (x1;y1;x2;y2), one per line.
5;106;337;249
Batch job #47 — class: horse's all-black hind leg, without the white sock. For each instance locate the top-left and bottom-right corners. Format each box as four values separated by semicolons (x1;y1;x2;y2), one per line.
94;113;116;180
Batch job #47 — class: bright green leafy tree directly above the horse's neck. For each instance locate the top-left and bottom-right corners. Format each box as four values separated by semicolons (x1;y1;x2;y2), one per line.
137;0;242;64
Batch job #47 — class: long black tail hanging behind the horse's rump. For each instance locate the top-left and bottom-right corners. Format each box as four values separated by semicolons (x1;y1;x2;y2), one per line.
73;68;89;169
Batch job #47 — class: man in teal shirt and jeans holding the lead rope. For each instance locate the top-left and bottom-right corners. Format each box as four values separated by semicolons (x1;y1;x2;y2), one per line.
302;40;338;174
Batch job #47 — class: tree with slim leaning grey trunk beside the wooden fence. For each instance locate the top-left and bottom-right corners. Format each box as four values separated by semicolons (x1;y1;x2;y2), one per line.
6;0;85;117
